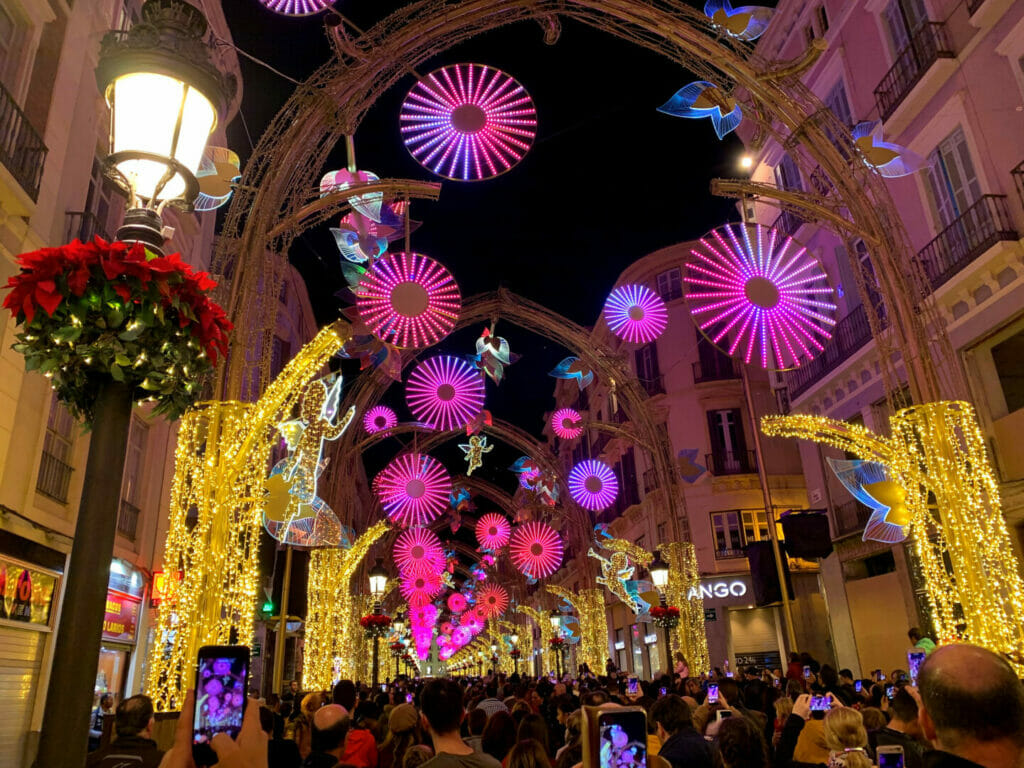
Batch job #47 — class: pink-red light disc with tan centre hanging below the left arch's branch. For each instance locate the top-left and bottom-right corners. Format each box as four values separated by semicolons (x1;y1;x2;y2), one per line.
353;252;462;348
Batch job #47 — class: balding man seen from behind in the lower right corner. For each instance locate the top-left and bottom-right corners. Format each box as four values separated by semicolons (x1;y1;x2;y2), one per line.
918;644;1024;768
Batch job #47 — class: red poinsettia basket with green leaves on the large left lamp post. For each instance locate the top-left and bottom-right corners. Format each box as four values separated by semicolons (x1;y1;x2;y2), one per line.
3;238;231;423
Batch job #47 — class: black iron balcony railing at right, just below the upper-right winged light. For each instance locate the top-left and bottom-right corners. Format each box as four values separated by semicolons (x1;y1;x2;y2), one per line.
918;195;1018;289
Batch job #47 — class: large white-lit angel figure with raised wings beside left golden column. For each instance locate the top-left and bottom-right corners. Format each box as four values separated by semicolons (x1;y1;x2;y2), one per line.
263;376;355;546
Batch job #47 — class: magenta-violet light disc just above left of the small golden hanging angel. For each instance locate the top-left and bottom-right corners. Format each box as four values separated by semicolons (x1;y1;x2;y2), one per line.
406;356;484;430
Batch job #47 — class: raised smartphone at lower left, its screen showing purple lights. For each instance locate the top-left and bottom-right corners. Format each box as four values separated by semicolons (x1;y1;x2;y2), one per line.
193;645;249;765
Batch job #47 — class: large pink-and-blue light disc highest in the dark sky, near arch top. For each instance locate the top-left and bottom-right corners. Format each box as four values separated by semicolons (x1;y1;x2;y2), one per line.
399;63;537;181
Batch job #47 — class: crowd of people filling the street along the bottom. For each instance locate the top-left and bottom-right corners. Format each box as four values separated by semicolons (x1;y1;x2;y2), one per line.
89;644;1024;768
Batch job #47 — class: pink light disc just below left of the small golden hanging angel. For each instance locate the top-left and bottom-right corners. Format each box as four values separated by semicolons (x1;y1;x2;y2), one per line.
374;454;452;525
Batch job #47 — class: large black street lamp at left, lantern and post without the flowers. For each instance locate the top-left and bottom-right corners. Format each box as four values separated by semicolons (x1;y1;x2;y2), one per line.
35;0;232;768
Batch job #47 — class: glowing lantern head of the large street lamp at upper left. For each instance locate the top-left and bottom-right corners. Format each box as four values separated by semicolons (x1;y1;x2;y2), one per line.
96;0;233;205
